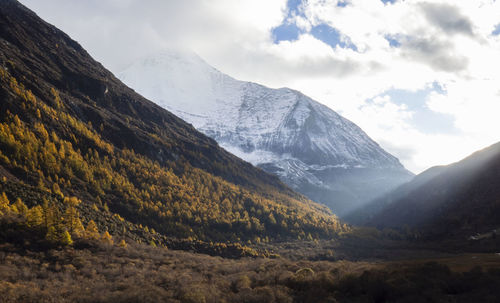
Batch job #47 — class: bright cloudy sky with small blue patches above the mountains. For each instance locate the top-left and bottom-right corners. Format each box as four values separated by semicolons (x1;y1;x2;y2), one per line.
21;0;500;173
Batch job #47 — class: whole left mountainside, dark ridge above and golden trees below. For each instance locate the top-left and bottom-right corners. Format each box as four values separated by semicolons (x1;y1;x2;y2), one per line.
0;0;341;246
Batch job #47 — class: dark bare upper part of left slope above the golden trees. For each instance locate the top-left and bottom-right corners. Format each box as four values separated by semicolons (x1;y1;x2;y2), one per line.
0;0;285;189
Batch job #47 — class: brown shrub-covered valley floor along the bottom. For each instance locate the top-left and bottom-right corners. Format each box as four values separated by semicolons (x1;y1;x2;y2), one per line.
0;241;500;302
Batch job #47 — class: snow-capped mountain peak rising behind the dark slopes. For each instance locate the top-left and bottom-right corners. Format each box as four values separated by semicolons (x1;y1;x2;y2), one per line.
119;51;412;215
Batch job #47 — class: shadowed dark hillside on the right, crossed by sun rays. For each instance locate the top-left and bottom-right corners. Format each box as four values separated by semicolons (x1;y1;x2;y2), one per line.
358;143;500;239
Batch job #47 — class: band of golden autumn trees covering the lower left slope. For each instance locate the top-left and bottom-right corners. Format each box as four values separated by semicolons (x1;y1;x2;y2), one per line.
0;68;347;243
